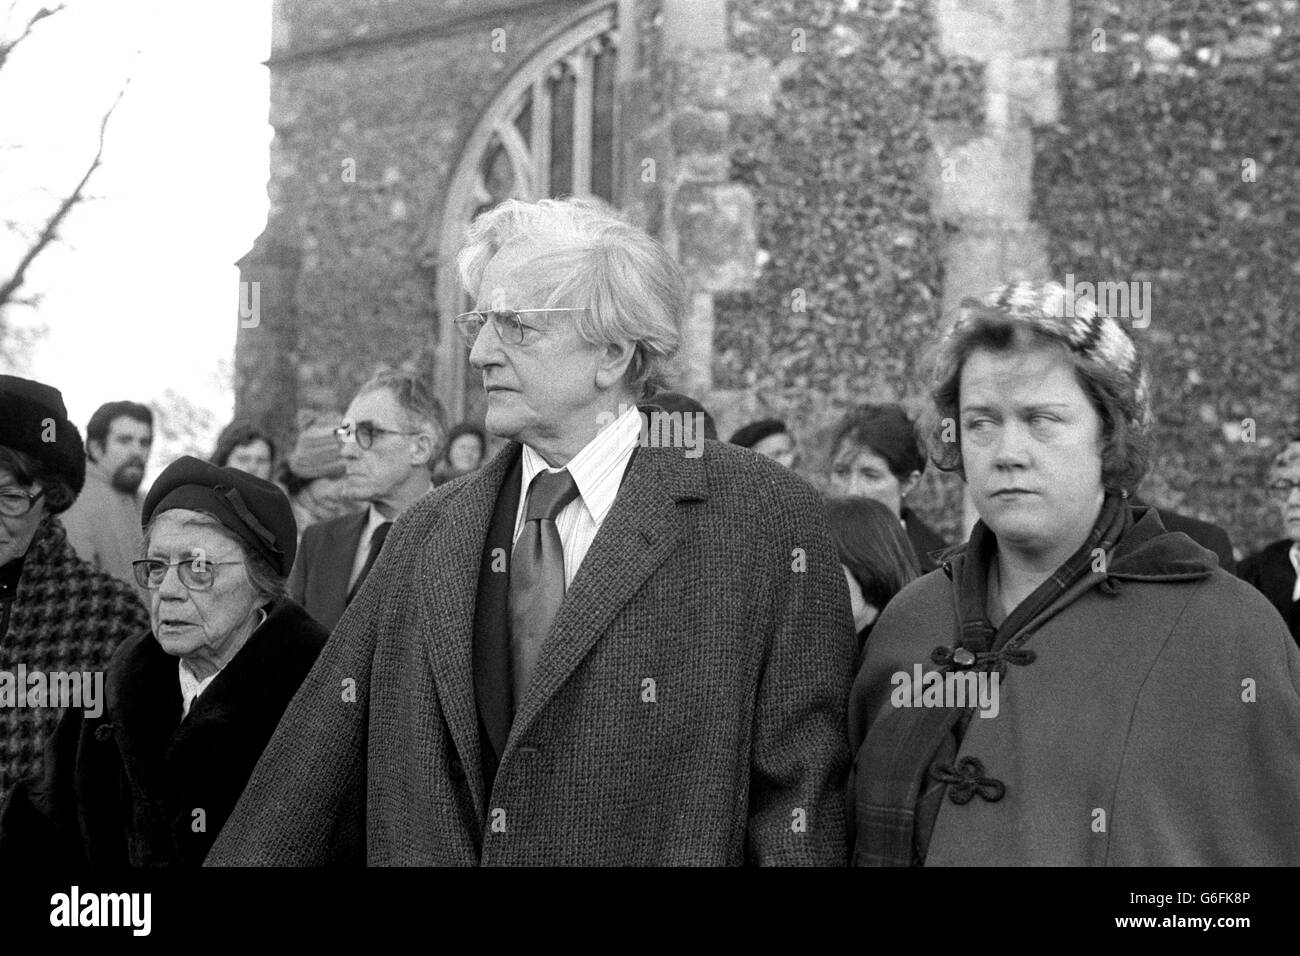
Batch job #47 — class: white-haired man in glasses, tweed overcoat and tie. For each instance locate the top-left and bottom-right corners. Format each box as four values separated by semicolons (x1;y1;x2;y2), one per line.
208;200;855;865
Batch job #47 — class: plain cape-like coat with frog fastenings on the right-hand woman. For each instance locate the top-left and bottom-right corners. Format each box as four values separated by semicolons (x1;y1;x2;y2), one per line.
849;507;1300;866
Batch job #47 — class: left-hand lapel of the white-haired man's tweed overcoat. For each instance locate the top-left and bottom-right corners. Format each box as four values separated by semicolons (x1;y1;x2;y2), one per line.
417;442;520;817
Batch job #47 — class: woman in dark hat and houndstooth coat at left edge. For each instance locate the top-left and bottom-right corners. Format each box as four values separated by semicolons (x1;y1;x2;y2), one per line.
0;375;148;799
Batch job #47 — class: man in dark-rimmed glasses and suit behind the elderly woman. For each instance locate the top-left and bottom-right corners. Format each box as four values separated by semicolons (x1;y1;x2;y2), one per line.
289;372;446;631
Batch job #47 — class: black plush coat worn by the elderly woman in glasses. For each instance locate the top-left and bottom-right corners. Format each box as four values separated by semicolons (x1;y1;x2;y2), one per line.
0;598;329;868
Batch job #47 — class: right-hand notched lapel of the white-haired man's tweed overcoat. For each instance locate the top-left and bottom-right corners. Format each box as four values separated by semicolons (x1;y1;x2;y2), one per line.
502;446;707;760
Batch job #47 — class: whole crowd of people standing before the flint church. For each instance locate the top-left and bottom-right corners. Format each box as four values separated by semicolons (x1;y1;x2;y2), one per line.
0;200;1300;866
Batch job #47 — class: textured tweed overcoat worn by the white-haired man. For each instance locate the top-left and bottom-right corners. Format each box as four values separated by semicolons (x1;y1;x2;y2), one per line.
208;441;855;865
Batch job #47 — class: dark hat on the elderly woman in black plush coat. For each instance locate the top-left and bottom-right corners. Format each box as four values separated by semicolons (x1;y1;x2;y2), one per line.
142;455;298;578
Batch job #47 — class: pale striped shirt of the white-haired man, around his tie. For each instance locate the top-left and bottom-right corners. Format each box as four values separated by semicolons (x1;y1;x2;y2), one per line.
514;406;641;588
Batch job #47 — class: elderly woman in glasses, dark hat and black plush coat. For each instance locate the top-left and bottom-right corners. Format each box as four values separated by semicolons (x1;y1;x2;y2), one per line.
0;457;328;866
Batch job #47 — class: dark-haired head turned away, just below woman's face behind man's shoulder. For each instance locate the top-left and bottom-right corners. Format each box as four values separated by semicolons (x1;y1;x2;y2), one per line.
827;498;920;653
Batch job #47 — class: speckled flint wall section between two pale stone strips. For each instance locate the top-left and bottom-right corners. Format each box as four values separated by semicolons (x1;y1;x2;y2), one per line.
714;0;983;535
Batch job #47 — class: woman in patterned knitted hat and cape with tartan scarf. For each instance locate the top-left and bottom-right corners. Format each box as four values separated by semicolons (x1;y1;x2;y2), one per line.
849;284;1300;866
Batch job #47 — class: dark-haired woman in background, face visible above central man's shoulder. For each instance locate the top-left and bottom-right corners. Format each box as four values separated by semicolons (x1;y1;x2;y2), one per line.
828;405;948;574
